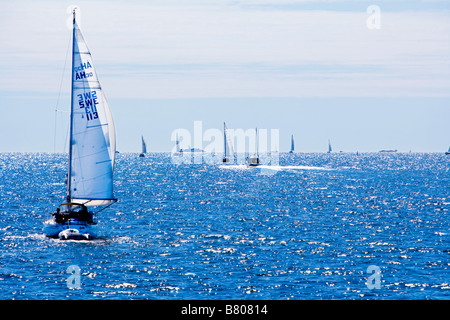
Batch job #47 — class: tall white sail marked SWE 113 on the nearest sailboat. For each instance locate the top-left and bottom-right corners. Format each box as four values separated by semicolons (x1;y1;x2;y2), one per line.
67;13;116;206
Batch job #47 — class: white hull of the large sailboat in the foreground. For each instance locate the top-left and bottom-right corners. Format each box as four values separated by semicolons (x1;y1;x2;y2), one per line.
44;219;97;240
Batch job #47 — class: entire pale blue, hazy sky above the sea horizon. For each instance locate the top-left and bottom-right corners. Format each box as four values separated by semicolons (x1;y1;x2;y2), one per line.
0;0;450;152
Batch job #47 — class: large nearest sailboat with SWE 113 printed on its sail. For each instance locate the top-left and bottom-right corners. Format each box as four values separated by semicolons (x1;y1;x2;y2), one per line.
44;9;117;240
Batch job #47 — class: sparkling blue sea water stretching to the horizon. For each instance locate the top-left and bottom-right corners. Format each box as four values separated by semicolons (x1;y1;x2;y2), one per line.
0;153;450;300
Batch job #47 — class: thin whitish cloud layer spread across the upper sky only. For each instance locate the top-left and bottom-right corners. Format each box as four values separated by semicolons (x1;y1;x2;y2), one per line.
0;0;450;98
